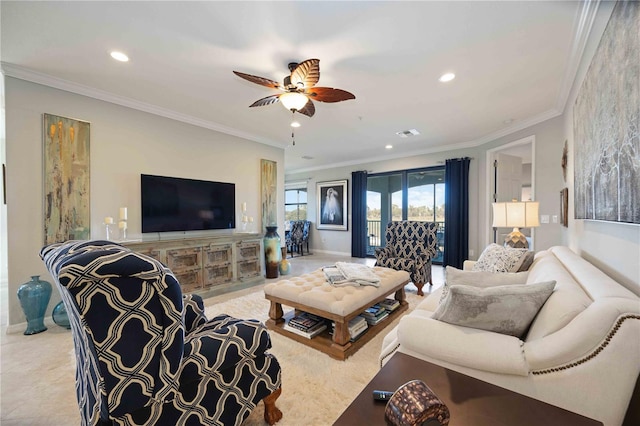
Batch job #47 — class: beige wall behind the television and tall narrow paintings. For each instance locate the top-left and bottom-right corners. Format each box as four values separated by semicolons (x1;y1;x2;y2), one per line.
3;77;284;325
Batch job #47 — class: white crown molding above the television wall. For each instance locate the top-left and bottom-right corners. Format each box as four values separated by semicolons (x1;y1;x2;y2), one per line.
0;62;283;148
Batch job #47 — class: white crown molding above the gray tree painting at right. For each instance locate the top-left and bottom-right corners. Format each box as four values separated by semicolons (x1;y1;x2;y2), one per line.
556;0;601;111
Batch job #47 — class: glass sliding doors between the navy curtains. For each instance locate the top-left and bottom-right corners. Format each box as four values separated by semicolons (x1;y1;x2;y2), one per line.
366;167;445;263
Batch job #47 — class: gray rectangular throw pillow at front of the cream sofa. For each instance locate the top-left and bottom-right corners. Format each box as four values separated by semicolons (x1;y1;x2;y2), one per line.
432;281;556;337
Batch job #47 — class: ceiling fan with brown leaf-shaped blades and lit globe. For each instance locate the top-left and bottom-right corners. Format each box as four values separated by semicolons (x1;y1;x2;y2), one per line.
233;59;356;117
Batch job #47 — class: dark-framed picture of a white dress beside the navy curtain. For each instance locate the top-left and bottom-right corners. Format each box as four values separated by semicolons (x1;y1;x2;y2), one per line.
316;180;347;231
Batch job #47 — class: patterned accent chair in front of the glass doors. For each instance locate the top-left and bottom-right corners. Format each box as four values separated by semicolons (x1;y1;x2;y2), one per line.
375;220;438;296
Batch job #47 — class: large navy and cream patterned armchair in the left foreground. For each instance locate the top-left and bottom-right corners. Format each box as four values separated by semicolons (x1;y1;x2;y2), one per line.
40;241;282;426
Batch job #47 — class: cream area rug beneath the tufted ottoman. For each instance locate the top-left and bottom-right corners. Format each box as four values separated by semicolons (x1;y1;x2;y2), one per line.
206;286;424;426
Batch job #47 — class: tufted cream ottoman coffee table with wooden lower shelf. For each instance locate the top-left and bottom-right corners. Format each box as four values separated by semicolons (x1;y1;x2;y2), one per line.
264;266;409;360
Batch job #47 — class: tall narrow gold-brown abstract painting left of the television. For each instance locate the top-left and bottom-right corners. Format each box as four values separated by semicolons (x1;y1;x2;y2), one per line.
43;114;91;245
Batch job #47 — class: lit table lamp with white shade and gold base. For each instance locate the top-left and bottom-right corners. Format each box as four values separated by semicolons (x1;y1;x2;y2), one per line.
493;201;540;248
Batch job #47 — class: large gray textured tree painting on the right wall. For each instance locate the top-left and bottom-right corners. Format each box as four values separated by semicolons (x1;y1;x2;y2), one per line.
574;1;640;224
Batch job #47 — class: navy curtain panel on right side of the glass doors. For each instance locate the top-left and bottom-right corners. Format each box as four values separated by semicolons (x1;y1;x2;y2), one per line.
442;158;471;269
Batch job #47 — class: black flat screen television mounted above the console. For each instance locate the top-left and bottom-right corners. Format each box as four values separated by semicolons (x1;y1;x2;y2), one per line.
140;175;236;233
